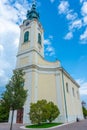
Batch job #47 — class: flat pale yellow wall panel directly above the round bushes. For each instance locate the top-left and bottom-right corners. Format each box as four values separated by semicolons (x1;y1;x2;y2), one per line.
38;74;57;104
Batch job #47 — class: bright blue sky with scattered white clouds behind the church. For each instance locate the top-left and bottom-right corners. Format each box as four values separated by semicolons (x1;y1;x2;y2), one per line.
0;0;87;103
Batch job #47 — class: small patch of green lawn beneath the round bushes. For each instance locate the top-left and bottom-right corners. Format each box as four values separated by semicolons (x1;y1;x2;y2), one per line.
26;123;62;128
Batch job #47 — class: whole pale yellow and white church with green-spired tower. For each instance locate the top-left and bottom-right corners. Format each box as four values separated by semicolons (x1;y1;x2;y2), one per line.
9;4;83;124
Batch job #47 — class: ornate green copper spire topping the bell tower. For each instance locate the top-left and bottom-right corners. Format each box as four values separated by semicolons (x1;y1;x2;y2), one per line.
26;0;39;20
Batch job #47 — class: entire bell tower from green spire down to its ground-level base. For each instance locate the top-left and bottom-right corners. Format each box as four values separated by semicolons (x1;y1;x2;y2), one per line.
14;1;44;123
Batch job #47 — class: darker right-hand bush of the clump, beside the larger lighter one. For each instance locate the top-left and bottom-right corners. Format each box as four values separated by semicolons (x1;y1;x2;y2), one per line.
47;102;60;122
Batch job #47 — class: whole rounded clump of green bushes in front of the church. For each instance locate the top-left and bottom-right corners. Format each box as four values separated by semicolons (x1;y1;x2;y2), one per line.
29;100;59;125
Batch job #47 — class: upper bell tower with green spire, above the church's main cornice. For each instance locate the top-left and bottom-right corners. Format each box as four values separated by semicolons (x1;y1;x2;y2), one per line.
16;1;44;68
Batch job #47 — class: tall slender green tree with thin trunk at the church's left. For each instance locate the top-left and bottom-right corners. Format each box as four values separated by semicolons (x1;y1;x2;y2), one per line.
2;70;27;130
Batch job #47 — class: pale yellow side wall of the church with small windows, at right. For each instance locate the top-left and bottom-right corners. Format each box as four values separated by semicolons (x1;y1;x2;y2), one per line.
64;75;82;116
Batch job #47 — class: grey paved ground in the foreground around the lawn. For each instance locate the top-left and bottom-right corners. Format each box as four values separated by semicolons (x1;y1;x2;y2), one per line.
0;119;87;130
